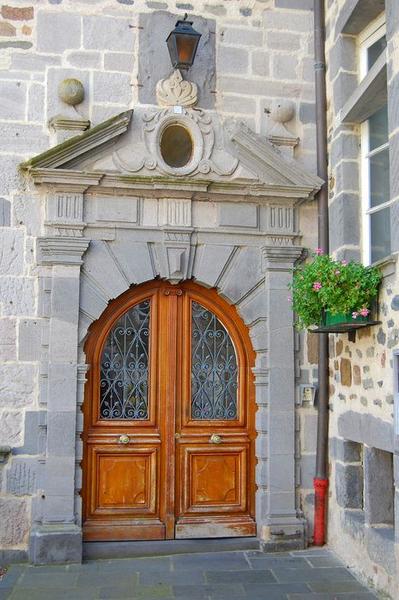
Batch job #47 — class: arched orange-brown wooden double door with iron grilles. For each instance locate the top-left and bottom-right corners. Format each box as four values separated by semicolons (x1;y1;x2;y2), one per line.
82;281;255;540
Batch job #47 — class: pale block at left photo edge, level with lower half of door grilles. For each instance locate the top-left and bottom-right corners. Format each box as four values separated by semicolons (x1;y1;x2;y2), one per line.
0;363;36;408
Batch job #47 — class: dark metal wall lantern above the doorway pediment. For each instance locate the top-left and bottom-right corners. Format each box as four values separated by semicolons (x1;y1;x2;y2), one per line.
166;15;201;70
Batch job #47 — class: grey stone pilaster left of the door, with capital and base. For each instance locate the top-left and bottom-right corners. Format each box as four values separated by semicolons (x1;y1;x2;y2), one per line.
30;236;89;564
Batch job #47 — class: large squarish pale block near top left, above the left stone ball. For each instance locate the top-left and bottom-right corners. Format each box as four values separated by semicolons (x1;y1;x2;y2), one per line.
37;10;81;54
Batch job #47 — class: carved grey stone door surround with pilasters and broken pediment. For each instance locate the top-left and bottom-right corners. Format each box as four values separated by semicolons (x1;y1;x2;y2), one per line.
25;106;320;564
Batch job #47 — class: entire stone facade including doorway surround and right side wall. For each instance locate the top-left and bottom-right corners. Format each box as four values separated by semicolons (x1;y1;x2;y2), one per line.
0;0;399;592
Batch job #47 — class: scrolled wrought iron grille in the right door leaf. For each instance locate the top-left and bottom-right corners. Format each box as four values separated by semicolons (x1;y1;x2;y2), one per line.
191;302;238;420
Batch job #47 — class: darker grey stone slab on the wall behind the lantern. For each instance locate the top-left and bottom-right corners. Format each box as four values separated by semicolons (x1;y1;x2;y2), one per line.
138;11;217;109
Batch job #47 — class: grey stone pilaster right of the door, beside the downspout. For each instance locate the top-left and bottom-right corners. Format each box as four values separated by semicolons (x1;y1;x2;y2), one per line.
258;246;304;550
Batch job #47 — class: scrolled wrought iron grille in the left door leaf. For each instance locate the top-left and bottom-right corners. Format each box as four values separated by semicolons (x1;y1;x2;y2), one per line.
100;300;150;420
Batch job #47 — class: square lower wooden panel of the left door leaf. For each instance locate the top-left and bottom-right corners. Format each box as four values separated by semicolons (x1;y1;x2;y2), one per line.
90;445;159;517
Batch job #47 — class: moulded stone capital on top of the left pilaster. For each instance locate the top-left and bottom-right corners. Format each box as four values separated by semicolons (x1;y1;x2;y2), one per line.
37;236;90;265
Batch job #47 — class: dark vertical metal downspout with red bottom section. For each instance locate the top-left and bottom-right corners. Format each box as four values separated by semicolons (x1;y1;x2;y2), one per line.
313;0;329;546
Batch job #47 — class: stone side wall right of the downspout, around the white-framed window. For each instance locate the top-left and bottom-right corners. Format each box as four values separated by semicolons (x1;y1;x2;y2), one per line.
326;0;399;597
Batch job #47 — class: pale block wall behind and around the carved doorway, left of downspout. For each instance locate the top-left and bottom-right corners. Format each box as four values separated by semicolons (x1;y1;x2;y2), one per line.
0;0;316;557
